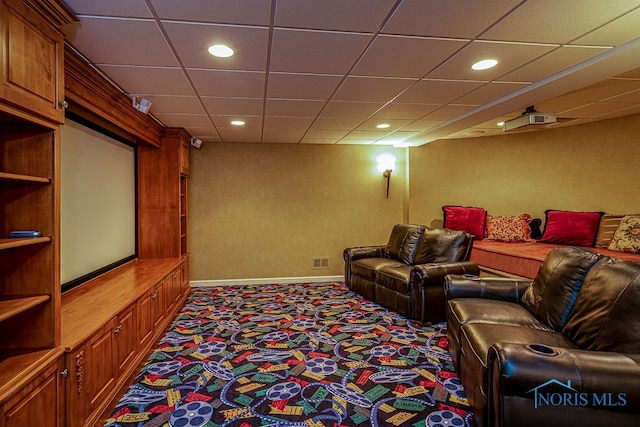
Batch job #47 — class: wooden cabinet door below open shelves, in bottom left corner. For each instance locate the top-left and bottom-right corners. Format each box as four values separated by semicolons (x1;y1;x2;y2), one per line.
0;357;64;427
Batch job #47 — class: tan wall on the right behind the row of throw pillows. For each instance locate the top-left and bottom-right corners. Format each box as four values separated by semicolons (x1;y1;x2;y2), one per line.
409;115;640;224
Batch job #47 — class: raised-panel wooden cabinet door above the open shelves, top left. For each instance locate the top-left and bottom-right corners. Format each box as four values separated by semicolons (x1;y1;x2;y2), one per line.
0;0;64;123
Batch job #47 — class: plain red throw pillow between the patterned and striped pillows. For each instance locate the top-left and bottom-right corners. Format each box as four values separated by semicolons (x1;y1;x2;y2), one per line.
540;210;602;246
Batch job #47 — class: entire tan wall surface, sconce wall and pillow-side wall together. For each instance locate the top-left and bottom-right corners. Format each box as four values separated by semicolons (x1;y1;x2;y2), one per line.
189;115;640;280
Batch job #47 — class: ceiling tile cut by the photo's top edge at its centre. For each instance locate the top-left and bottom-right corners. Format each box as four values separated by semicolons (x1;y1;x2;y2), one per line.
275;0;396;32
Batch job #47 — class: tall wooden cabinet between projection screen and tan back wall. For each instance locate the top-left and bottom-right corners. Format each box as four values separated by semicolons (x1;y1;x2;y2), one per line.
138;128;191;258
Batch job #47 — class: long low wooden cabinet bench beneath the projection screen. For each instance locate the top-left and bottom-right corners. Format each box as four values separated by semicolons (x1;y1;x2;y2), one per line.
61;258;188;427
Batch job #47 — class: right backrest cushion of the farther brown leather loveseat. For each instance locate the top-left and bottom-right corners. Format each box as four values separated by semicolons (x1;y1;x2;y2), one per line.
414;228;473;264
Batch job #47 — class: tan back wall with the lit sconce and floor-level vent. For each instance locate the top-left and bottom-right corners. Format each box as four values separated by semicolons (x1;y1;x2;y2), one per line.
189;143;406;280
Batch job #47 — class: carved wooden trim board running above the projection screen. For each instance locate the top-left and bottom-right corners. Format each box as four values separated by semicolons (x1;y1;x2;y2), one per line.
64;44;163;147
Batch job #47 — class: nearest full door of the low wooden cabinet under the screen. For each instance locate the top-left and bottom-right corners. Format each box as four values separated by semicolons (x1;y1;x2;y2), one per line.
84;319;116;414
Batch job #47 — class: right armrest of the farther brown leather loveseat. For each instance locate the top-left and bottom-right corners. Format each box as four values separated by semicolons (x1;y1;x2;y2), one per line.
409;261;480;322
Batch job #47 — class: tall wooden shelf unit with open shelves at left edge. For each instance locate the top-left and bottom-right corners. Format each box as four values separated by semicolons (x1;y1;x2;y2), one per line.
0;0;74;427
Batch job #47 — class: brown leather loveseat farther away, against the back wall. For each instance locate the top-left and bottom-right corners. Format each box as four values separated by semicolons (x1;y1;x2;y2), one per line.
343;224;479;322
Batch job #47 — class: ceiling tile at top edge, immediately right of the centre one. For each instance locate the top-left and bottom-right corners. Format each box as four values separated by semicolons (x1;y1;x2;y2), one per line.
382;0;521;39
